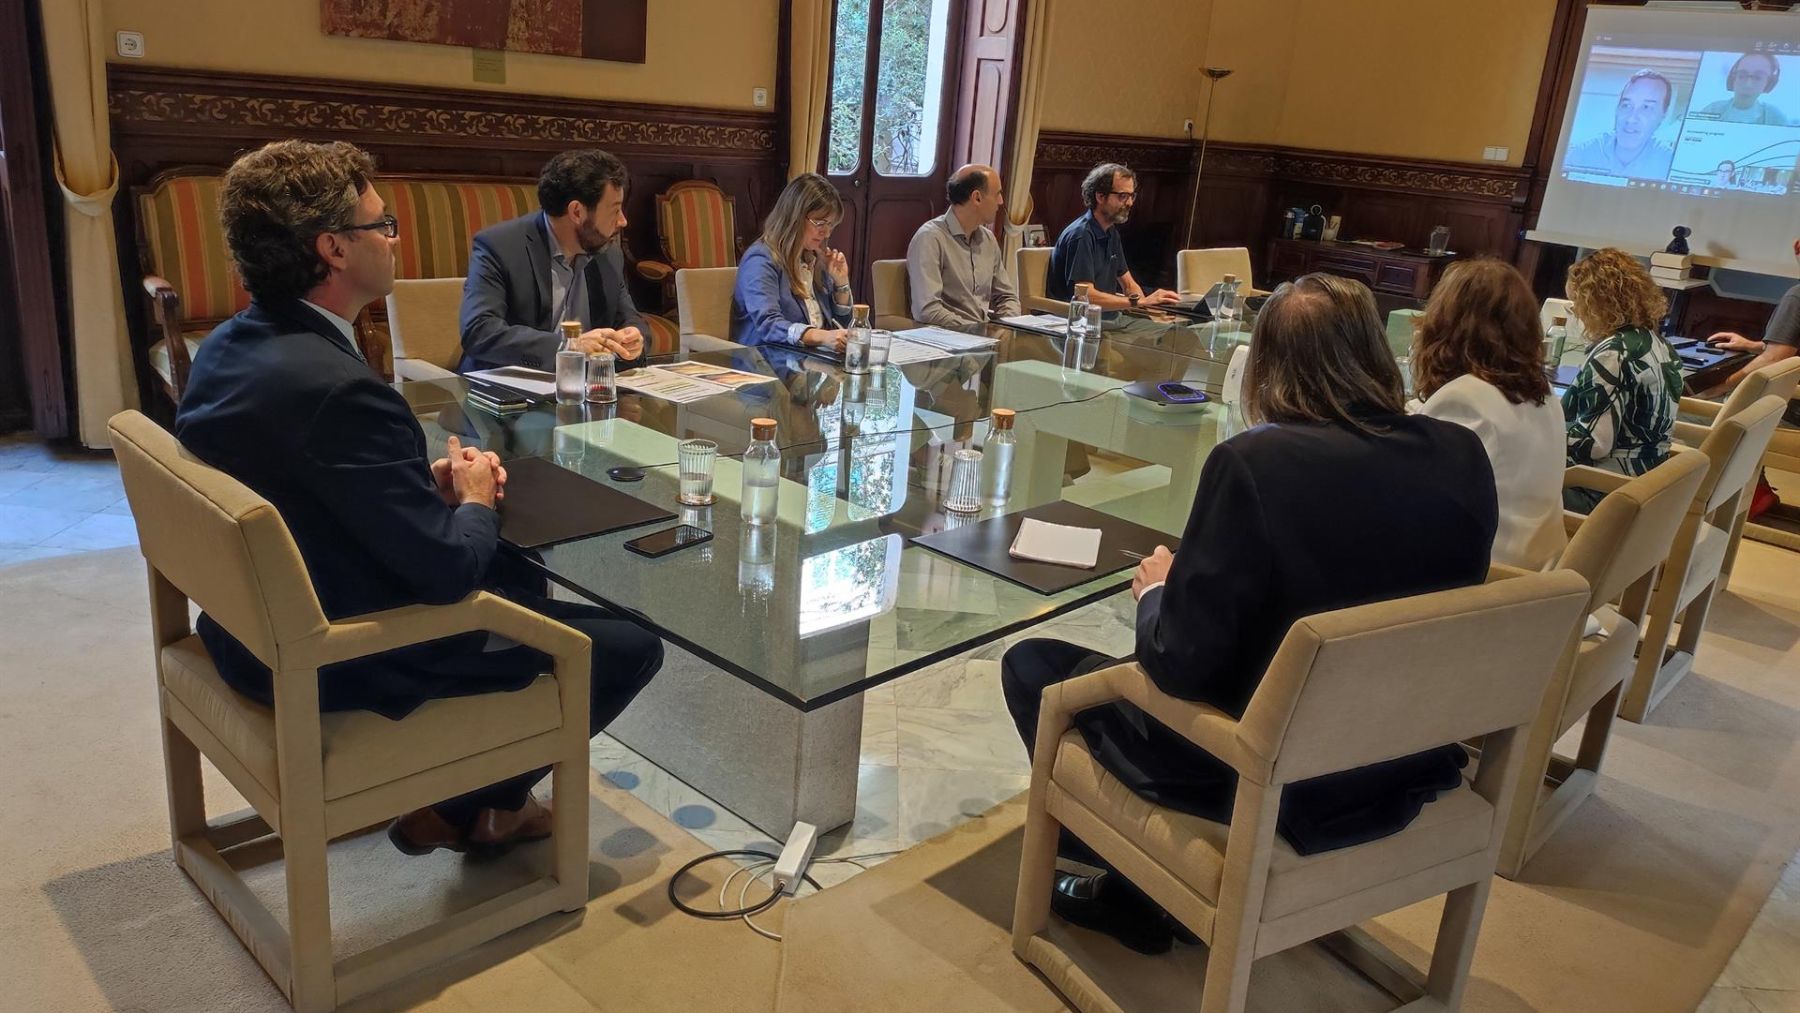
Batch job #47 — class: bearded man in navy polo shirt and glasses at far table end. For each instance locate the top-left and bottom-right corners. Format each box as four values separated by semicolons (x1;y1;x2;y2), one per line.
1044;162;1181;309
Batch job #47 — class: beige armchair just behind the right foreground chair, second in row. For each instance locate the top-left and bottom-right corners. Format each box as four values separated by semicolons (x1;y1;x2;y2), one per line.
1490;450;1710;880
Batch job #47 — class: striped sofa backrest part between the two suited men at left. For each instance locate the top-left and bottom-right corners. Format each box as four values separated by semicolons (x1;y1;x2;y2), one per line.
374;180;538;279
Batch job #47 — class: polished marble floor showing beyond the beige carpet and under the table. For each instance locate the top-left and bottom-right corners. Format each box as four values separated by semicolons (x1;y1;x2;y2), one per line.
0;435;1800;1013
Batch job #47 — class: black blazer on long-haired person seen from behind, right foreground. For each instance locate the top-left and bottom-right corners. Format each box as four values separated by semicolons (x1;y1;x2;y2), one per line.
1078;416;1498;853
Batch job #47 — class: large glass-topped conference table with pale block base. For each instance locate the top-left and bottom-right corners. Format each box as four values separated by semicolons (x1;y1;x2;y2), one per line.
398;317;1249;840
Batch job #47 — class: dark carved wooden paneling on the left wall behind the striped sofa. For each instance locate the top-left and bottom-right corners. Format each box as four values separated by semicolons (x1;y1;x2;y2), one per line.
108;65;787;403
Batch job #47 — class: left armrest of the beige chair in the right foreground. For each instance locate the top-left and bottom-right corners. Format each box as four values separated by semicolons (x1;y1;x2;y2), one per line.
1039;662;1274;784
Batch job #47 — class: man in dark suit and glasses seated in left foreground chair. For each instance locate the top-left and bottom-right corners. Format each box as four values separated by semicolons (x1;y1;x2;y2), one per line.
175;140;662;855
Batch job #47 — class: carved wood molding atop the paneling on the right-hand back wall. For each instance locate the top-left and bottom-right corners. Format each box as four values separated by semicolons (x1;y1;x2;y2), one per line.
1037;133;1530;203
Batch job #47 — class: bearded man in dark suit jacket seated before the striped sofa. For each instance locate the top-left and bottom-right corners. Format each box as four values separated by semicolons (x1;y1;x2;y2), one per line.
459;149;644;372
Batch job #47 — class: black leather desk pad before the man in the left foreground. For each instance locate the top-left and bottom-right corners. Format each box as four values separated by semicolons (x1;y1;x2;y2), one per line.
500;457;675;549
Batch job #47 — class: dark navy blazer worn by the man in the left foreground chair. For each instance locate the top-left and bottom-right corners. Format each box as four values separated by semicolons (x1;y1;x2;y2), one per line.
175;300;535;718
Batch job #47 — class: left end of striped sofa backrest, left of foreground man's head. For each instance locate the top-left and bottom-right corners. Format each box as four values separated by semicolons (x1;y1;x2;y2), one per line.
137;176;250;320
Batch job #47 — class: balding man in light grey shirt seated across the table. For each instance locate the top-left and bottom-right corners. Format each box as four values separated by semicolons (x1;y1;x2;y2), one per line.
905;166;1021;333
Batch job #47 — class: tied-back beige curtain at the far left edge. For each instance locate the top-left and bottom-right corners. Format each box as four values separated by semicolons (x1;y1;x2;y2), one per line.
40;0;137;448
